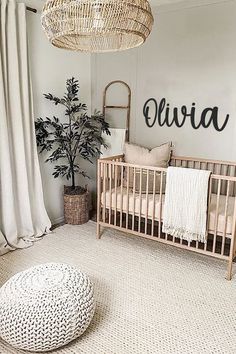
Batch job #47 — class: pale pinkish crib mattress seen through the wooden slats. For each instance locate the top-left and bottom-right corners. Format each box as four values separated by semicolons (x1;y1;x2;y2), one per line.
101;187;235;235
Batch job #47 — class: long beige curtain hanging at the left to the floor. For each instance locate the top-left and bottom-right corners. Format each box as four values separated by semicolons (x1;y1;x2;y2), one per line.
0;0;51;254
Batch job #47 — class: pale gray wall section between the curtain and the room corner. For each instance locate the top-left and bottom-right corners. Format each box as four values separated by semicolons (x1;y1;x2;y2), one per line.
27;13;91;224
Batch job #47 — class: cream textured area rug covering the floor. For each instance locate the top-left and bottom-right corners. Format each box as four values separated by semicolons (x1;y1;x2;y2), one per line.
0;222;236;354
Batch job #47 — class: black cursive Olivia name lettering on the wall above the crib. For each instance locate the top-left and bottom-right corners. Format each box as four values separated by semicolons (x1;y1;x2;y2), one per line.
143;98;229;132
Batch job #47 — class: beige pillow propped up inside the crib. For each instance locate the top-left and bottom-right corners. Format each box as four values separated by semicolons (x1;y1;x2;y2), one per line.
124;143;171;193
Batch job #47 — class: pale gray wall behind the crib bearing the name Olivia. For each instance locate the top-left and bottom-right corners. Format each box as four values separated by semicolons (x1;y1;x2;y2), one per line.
92;1;236;161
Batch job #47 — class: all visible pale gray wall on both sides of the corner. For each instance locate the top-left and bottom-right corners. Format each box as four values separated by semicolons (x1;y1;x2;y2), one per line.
27;1;236;223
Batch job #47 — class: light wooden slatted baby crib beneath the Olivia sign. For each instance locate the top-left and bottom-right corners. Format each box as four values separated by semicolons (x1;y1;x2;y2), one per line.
97;155;236;280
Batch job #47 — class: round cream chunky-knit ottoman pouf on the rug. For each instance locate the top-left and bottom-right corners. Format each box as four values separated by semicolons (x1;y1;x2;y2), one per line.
0;263;95;352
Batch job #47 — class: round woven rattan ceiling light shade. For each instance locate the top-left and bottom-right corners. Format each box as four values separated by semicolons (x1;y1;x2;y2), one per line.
41;0;153;52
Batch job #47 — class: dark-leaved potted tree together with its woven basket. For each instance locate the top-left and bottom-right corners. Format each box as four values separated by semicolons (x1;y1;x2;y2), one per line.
35;77;110;225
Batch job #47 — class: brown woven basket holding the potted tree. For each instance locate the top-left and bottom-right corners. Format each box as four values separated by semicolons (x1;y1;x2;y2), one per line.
64;187;89;225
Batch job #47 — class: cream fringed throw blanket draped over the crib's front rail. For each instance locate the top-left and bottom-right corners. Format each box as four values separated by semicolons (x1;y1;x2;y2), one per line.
162;167;211;242
